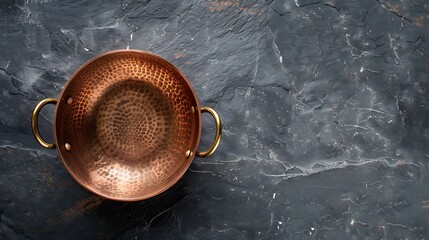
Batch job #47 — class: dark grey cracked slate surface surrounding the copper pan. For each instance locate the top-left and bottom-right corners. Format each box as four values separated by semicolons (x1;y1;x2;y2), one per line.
0;0;429;240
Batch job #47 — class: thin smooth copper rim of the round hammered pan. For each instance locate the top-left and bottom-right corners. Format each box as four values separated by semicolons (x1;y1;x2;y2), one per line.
53;49;202;202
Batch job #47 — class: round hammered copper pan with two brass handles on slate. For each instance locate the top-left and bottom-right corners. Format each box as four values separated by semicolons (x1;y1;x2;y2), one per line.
32;50;222;201
